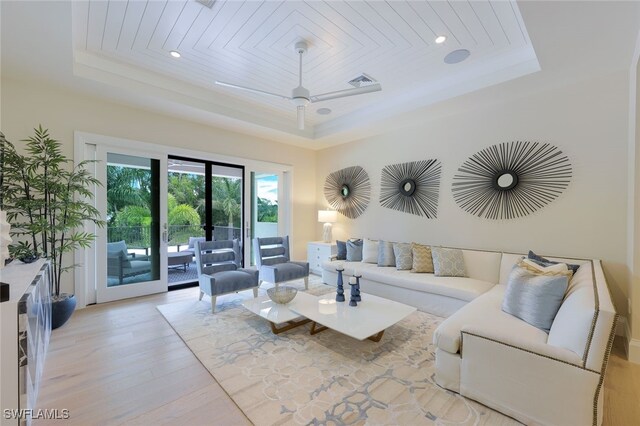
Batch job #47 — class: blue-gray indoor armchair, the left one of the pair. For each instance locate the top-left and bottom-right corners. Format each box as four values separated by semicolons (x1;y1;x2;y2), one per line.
196;240;258;313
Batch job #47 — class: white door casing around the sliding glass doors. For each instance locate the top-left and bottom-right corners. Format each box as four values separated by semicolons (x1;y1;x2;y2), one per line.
74;131;294;308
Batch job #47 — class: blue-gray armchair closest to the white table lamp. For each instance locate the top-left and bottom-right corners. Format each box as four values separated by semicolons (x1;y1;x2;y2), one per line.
253;236;309;290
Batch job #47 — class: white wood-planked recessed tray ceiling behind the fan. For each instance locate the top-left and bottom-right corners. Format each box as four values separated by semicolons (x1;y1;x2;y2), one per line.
73;0;539;143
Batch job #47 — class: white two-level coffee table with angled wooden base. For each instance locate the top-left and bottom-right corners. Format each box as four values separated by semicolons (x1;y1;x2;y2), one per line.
243;292;416;342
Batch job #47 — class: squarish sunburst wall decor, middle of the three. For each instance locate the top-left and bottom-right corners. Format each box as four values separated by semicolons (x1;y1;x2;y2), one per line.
380;160;442;219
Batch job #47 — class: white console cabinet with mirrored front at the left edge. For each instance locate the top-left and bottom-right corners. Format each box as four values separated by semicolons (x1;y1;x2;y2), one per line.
0;260;51;426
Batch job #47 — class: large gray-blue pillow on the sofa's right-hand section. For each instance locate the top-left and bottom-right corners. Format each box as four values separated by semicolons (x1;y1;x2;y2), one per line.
502;262;569;333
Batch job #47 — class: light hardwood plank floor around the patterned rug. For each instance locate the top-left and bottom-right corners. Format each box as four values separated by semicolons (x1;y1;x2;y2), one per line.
34;288;640;426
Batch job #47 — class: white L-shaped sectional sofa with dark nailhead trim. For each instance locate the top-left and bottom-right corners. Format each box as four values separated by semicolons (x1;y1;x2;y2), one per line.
322;249;617;425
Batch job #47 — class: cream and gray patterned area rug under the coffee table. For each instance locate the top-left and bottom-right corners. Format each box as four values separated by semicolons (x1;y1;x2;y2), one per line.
158;280;519;425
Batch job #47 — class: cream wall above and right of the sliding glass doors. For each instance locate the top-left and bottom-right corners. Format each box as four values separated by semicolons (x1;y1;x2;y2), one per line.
1;77;316;291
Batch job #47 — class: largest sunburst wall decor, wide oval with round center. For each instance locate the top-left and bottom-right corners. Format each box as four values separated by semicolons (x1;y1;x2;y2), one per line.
452;141;571;219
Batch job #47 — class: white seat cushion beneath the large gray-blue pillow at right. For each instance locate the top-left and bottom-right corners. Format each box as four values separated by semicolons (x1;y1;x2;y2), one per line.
433;285;547;354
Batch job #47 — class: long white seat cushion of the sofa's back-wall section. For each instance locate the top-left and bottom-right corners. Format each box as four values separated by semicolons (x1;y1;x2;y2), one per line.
360;268;495;302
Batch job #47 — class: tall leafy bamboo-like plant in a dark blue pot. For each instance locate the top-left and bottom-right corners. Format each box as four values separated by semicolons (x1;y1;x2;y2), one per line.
1;126;104;328
